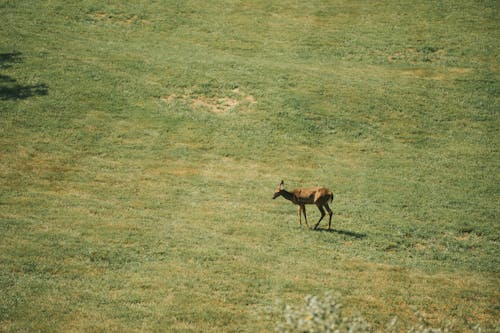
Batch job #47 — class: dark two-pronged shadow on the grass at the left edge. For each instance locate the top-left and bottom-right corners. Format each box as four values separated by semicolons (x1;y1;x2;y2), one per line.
0;52;49;101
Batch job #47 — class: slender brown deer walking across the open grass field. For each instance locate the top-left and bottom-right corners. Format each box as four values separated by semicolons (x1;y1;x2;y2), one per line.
273;181;333;230
